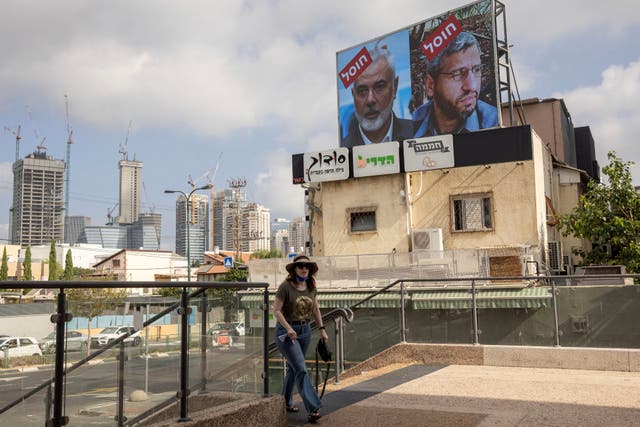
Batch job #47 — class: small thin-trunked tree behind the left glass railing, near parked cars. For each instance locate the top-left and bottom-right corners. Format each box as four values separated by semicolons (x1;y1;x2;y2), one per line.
66;288;127;355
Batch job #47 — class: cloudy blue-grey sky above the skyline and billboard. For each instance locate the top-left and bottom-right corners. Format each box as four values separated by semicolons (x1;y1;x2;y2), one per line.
0;0;640;249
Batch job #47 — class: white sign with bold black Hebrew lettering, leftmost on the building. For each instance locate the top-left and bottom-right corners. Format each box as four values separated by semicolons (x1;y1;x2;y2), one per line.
303;148;349;182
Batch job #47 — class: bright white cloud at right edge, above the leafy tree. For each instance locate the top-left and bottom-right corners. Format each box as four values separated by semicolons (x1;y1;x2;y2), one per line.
553;59;640;182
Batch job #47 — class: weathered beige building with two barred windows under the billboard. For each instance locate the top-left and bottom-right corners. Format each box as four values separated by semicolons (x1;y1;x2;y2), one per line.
307;99;597;276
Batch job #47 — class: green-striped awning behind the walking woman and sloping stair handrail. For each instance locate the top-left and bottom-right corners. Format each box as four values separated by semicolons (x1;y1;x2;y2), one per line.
240;292;402;308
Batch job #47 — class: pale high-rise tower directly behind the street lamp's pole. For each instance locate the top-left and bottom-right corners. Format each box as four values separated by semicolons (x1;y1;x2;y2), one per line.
176;194;209;262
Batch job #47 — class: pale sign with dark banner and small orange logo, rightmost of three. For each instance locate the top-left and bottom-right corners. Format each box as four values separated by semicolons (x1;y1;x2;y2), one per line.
402;135;454;172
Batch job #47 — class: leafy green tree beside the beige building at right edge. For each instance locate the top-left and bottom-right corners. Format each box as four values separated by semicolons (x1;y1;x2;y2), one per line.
559;151;640;273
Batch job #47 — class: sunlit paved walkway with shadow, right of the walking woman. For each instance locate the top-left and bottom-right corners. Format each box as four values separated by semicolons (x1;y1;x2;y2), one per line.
288;365;640;427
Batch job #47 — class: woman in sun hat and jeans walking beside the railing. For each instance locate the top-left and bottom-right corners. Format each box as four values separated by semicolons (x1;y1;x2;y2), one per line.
273;255;329;423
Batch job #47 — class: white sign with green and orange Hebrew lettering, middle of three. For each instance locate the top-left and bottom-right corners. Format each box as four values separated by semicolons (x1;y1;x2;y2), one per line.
352;141;400;178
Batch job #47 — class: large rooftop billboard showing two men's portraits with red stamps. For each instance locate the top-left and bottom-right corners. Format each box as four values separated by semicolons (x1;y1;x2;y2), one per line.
336;0;500;148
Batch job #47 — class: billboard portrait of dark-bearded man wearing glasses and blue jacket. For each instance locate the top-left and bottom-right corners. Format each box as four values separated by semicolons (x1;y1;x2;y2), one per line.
413;31;498;138
